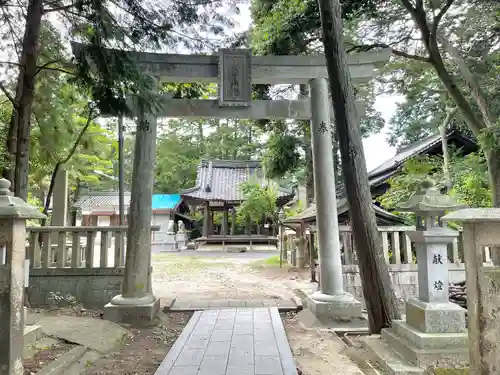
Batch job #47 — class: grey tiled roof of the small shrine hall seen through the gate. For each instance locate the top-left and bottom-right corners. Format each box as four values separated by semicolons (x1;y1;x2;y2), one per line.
180;160;293;201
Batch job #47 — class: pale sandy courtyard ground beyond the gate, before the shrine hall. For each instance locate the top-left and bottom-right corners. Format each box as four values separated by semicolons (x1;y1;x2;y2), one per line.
152;252;301;300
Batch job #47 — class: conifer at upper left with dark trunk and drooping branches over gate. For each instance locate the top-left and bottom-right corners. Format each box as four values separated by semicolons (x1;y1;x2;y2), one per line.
0;0;239;199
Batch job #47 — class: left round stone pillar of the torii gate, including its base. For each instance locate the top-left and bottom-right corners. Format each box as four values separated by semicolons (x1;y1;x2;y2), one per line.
104;98;160;322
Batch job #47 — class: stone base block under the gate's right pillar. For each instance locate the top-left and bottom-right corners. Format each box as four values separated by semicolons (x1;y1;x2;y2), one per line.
306;292;363;319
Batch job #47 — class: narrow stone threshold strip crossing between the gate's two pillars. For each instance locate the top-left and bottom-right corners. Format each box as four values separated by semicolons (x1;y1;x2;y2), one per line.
164;297;303;312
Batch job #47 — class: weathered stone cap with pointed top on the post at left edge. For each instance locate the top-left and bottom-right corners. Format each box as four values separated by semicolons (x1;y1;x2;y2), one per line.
0;178;46;219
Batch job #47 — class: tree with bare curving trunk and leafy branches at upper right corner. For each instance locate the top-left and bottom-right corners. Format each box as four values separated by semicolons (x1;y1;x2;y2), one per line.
353;0;500;206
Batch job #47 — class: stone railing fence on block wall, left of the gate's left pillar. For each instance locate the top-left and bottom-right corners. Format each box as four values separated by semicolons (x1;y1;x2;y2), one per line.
19;226;159;309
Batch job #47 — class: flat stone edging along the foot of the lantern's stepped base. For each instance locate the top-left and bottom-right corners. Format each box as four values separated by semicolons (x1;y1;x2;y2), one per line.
362;335;424;375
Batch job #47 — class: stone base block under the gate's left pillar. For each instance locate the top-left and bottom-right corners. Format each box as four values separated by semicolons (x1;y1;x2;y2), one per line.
103;296;160;324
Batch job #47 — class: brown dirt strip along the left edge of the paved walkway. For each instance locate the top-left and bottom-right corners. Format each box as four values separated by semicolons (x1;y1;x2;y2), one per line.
83;313;192;375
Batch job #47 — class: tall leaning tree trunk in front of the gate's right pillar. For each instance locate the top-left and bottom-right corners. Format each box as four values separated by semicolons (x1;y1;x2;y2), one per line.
318;0;397;333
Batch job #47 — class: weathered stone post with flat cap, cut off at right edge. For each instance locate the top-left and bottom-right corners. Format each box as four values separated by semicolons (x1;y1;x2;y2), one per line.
442;208;500;375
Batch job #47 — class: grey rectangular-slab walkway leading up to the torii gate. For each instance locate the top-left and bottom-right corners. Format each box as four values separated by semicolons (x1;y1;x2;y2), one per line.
155;307;297;375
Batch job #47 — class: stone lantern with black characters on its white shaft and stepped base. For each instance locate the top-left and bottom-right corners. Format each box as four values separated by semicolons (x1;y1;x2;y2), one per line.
367;179;468;369
